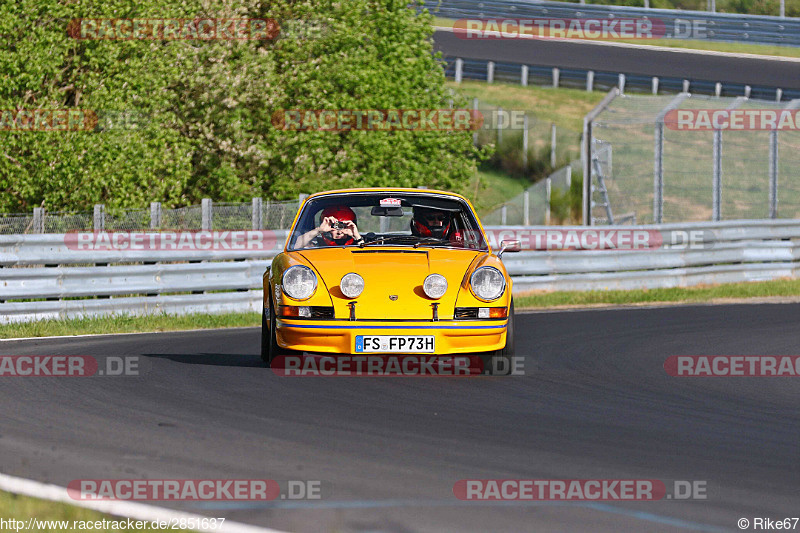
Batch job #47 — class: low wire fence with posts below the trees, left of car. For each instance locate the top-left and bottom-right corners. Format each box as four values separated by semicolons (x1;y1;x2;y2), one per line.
0;196;302;235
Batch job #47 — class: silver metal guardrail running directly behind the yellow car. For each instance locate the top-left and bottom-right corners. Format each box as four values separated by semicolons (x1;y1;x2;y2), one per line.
0;220;800;323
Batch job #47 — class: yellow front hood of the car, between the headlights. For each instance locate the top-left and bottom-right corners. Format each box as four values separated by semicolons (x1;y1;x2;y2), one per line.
300;247;478;320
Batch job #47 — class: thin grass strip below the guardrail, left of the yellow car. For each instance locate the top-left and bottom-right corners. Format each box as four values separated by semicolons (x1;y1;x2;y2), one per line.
0;313;261;339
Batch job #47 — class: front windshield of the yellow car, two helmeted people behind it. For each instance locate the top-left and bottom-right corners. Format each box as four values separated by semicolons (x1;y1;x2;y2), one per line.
288;192;488;250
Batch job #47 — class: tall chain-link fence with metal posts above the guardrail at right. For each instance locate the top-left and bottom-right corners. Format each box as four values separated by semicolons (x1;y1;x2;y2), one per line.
591;93;800;224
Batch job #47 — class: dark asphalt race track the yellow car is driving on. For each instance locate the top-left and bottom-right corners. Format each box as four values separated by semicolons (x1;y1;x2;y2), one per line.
0;304;800;533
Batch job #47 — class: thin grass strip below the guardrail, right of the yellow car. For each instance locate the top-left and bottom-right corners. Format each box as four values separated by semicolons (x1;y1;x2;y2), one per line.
514;279;800;309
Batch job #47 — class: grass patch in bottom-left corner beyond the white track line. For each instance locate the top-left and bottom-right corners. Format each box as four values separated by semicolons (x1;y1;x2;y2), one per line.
0;491;169;533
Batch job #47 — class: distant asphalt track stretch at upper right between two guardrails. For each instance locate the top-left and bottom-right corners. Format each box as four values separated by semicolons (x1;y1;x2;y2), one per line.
434;30;800;89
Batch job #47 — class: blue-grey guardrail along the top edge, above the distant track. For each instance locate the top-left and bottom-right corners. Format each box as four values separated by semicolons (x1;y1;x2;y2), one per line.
434;0;800;46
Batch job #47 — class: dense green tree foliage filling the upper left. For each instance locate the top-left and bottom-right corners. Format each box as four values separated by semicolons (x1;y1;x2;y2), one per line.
0;0;483;212
